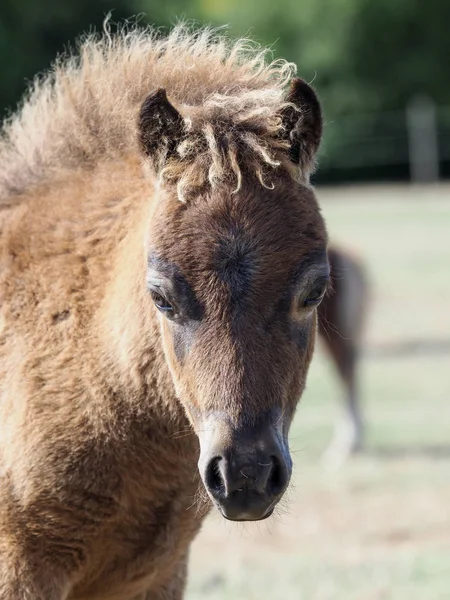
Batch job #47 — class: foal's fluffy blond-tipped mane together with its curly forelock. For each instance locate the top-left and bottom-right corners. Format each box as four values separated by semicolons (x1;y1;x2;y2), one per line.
0;24;301;199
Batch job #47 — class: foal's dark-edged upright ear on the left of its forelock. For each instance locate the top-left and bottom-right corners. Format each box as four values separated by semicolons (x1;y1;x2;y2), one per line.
139;88;185;171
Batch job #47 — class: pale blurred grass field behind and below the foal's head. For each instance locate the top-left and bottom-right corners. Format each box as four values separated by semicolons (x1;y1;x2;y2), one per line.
187;187;450;600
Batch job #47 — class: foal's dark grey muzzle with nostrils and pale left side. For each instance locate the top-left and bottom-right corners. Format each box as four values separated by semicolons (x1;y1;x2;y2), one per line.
199;418;292;521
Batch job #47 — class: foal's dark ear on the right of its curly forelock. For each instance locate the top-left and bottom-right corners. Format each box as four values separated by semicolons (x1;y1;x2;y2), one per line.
281;77;322;179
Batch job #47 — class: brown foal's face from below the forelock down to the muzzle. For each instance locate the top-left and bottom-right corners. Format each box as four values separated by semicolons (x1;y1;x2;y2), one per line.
147;180;329;520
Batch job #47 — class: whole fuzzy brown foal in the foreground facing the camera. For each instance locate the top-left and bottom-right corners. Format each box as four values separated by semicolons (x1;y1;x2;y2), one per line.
0;26;329;600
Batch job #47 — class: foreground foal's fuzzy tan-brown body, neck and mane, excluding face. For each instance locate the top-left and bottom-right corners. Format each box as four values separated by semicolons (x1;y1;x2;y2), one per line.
0;23;326;600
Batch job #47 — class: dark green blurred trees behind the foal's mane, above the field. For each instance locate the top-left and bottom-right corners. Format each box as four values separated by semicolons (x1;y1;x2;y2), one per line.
0;0;450;181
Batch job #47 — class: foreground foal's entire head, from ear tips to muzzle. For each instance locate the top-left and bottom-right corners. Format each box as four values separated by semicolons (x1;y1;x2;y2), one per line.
140;79;329;521
